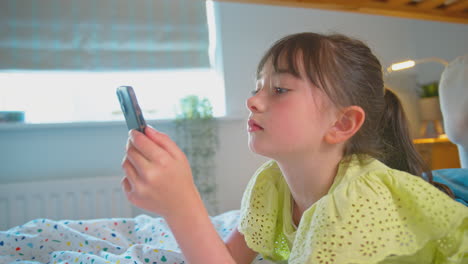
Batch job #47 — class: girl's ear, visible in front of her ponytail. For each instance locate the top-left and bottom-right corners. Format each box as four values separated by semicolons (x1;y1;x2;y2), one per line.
325;105;366;144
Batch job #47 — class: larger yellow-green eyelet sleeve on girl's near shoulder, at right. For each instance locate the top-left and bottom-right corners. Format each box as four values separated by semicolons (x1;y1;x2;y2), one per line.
289;161;468;264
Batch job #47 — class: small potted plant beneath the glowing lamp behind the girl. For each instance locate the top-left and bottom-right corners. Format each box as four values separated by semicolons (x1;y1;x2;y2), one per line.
419;81;443;137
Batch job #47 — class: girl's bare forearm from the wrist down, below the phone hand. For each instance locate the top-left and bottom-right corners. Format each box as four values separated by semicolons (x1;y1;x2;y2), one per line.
166;192;235;264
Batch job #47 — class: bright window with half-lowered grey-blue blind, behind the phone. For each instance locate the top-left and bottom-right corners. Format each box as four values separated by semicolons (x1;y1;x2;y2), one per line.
0;0;225;123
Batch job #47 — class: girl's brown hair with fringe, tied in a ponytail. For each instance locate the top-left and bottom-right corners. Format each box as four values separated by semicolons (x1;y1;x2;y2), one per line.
257;33;453;197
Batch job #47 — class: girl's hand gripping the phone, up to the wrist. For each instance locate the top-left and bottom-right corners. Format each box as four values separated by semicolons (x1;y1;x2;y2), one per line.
122;127;200;217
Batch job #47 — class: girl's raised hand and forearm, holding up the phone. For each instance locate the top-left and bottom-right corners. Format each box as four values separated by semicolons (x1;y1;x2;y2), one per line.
122;127;235;264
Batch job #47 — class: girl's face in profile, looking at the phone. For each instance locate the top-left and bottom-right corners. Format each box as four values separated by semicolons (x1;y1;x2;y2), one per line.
247;59;336;160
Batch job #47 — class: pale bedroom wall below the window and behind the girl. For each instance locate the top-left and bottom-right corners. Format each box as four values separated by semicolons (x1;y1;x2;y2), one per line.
0;2;468;217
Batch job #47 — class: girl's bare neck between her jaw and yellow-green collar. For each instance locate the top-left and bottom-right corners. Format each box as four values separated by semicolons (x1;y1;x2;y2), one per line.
277;152;343;224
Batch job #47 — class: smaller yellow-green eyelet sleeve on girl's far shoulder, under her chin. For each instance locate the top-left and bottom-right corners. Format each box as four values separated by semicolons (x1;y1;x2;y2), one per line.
238;161;291;261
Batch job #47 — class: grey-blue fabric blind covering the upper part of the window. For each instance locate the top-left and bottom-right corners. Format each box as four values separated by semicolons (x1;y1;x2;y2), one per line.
0;0;209;71
